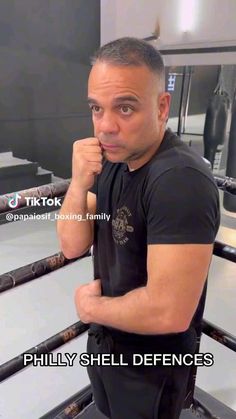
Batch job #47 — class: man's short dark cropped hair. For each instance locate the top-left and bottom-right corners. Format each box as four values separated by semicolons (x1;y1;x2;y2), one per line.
91;37;165;89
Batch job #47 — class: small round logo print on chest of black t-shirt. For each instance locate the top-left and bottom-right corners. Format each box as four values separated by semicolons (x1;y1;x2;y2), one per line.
112;206;134;245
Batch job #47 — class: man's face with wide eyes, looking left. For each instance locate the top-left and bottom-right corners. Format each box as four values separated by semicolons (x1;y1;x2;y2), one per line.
88;61;170;169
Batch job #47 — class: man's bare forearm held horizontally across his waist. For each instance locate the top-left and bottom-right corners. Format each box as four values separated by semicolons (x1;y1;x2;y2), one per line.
89;287;175;334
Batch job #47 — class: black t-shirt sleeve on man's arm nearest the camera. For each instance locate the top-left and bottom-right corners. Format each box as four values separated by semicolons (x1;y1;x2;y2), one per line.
145;167;220;244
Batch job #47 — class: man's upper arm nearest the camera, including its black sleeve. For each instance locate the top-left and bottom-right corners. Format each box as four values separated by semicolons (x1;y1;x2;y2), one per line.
143;168;219;329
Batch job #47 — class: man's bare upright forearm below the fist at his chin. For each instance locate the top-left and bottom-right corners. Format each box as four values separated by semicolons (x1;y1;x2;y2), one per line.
57;183;93;258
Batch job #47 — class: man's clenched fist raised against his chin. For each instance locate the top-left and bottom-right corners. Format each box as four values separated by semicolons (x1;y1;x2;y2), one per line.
72;137;102;191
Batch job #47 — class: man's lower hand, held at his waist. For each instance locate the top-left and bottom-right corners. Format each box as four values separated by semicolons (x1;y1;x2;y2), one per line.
75;279;101;323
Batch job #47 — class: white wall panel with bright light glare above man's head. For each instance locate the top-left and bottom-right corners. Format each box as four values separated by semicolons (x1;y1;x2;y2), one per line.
101;0;236;47
